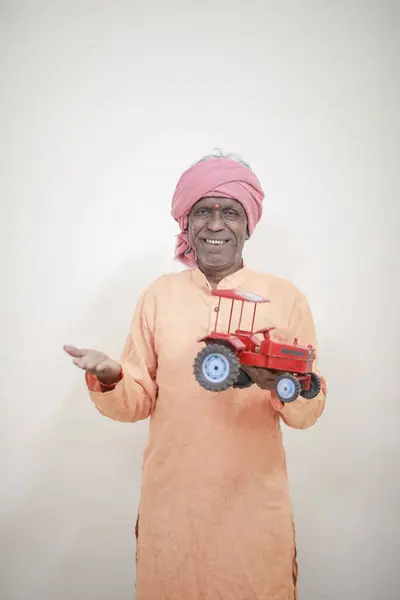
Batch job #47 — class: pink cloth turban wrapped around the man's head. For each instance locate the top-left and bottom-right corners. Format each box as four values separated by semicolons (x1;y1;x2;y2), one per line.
171;158;264;267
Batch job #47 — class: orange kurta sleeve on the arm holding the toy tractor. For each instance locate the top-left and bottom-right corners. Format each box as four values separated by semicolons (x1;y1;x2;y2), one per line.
273;293;327;429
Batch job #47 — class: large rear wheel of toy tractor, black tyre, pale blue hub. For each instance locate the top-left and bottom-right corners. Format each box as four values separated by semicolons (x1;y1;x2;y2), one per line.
194;344;239;392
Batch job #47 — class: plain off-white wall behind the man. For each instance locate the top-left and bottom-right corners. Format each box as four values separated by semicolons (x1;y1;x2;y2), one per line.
0;0;400;600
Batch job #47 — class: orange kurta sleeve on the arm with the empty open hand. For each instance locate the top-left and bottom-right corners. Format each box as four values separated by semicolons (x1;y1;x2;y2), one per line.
86;292;158;422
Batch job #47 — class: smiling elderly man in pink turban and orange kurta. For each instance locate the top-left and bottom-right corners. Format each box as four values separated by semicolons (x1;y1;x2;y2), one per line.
65;156;326;600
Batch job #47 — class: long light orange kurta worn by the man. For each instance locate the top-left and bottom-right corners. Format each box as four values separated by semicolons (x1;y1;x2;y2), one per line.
88;267;326;600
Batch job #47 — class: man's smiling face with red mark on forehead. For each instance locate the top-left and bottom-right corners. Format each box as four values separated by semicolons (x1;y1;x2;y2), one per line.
188;198;247;270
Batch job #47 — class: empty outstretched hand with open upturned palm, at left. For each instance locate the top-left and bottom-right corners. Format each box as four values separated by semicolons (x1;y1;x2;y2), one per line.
64;345;122;385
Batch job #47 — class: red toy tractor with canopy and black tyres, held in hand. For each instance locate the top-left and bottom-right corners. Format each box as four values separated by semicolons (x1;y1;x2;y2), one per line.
194;290;321;402
